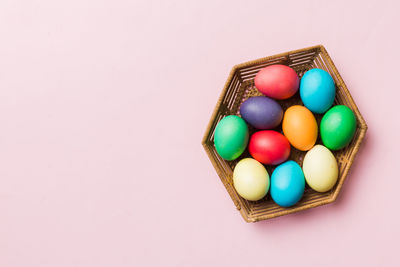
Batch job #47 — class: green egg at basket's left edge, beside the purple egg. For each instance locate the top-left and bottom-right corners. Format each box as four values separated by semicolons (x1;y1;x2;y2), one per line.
214;115;249;160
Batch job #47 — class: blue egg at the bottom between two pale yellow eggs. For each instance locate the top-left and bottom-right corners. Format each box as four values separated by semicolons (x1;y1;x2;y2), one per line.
270;160;305;207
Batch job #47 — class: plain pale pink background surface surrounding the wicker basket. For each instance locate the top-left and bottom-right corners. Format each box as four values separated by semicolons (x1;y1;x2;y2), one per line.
0;0;400;267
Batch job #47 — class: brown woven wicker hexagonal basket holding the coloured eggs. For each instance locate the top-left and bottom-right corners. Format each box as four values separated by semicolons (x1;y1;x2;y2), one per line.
202;45;367;222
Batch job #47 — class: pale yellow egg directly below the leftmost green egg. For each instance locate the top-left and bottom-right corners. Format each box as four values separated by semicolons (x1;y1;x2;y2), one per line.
233;158;269;201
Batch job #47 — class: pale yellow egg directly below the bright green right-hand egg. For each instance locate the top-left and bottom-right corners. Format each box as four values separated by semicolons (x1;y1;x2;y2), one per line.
303;145;339;193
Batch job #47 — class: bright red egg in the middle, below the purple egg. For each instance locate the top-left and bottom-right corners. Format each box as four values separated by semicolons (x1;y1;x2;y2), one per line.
249;130;290;165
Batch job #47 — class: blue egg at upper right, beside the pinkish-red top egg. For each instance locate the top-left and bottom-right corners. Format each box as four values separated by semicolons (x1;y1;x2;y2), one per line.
300;69;335;114
